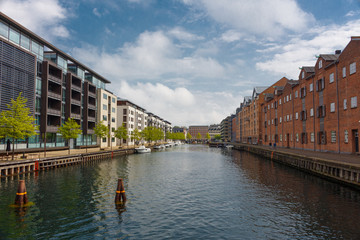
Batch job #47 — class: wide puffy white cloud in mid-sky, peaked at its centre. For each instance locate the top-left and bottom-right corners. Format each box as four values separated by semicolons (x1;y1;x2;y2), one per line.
72;31;227;81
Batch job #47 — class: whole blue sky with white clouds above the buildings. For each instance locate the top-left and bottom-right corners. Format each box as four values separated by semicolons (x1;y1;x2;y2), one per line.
0;0;360;126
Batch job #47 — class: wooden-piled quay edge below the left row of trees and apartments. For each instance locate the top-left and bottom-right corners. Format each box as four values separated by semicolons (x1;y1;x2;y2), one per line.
0;149;134;177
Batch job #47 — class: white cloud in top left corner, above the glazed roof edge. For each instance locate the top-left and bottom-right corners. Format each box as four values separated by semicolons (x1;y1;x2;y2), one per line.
0;0;70;41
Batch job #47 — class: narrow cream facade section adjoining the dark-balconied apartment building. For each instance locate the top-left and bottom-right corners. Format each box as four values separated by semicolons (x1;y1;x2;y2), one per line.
97;88;117;148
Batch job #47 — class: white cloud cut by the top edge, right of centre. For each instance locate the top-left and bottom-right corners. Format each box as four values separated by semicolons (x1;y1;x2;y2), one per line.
183;0;314;38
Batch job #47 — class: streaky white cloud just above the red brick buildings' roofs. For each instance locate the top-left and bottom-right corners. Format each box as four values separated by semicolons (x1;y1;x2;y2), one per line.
256;20;360;78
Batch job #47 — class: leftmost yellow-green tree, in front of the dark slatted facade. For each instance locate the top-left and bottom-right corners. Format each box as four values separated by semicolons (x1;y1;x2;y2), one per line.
0;92;38;159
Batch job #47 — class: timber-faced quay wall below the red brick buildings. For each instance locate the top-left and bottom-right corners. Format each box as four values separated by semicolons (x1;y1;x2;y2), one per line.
209;143;360;190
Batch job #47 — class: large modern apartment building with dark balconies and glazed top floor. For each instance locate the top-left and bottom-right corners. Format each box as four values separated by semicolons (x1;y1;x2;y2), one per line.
0;12;110;148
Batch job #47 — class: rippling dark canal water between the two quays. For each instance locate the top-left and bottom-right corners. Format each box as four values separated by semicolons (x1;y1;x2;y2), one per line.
0;145;360;239
